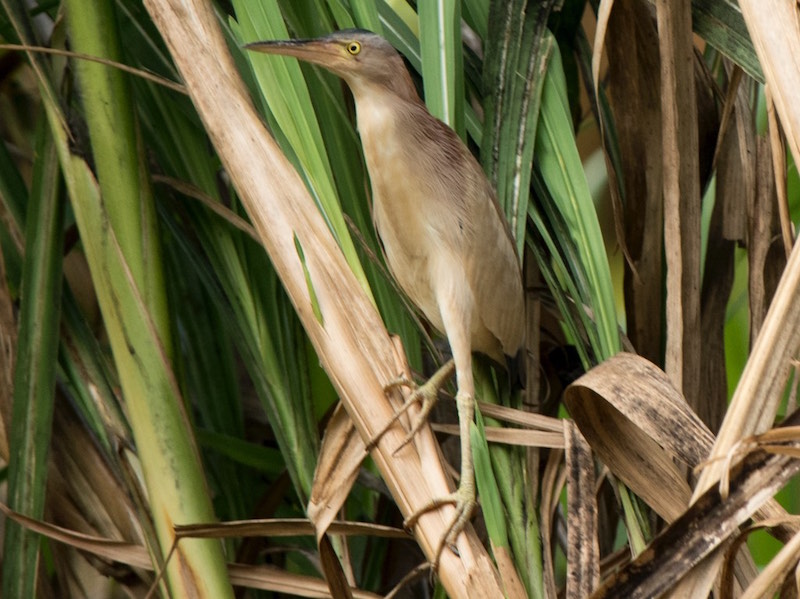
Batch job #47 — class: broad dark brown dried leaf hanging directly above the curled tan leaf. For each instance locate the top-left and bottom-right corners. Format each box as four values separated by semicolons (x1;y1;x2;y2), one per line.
606;0;664;362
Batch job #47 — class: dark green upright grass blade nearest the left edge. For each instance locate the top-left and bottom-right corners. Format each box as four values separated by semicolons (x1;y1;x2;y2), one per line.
2;117;64;597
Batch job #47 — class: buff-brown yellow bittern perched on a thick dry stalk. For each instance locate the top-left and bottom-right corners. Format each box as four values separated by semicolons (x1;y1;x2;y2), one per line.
246;29;525;561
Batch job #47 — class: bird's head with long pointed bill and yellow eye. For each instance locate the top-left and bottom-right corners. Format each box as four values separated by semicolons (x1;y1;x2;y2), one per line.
245;29;408;98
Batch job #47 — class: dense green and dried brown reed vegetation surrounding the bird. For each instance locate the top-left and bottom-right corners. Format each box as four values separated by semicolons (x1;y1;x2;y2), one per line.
0;0;800;597
